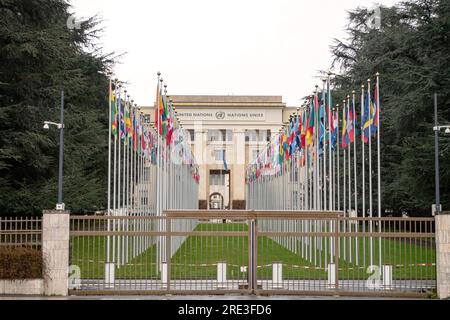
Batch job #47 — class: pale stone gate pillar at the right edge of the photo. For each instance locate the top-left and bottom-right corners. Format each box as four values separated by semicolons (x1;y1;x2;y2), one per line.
436;214;450;299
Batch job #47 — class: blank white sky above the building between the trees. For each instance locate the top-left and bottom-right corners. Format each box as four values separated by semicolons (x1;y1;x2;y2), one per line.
70;0;398;106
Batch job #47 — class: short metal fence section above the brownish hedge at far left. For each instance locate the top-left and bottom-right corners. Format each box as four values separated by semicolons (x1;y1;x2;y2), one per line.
0;217;42;250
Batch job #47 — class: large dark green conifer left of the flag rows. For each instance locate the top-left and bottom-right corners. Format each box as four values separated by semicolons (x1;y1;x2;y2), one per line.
0;0;113;215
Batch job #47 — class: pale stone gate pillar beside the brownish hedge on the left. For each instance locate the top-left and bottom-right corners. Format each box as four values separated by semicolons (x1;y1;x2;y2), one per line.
42;210;70;296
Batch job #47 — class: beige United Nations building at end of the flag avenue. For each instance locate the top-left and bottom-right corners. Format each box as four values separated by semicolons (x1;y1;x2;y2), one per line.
141;95;295;209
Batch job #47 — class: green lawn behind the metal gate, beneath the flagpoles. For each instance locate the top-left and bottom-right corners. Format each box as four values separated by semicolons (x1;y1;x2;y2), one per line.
71;223;436;280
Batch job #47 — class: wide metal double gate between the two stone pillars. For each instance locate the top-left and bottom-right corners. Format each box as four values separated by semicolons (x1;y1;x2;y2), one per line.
70;211;436;296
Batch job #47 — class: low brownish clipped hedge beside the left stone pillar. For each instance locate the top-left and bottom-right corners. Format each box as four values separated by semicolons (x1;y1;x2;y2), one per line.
0;246;44;280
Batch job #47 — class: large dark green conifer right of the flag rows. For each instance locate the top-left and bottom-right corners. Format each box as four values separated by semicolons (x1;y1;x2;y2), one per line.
332;0;450;214
